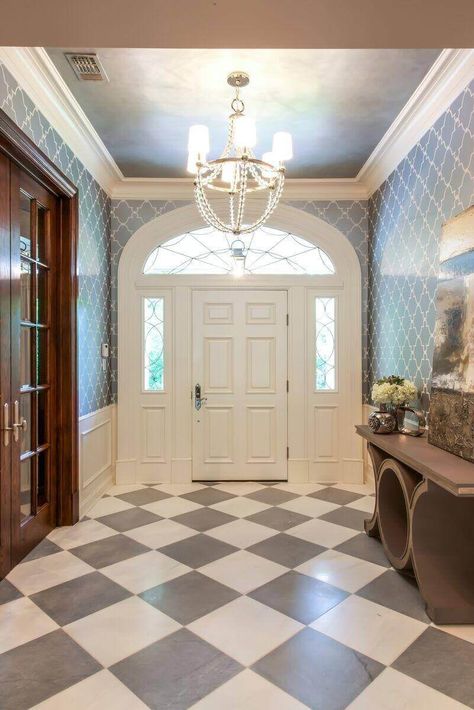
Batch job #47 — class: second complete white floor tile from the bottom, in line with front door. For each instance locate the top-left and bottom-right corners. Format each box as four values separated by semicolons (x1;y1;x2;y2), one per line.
199;550;288;594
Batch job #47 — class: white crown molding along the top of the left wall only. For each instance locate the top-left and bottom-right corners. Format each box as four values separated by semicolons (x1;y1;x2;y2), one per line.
0;47;123;195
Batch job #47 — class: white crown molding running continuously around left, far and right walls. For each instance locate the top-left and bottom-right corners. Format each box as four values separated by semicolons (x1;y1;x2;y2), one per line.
0;47;474;200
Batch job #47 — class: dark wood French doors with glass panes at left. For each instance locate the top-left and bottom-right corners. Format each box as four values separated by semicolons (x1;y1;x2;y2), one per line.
0;155;59;573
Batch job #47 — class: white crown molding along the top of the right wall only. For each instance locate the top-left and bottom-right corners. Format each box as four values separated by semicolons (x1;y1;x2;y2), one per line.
356;49;474;195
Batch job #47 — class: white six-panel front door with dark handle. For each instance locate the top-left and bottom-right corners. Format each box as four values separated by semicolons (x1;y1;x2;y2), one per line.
192;290;288;480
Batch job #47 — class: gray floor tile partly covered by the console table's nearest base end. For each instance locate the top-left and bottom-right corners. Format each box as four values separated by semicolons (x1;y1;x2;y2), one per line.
357;569;431;624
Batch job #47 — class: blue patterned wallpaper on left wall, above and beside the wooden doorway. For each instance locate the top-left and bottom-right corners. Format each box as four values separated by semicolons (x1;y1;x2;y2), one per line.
0;63;112;415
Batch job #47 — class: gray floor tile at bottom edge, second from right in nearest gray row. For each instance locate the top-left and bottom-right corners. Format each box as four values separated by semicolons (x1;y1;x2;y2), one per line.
253;629;383;710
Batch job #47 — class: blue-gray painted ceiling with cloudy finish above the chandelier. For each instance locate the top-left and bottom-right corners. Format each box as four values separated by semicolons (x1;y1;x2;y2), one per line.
47;47;440;178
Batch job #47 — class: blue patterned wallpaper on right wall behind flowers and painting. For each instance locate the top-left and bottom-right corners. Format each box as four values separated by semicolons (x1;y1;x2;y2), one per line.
368;82;474;404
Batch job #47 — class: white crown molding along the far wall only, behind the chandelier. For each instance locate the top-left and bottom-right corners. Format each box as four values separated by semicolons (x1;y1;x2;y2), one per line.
111;178;368;201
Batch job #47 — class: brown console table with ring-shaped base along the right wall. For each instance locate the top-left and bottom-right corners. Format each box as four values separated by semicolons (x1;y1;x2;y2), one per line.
356;426;474;624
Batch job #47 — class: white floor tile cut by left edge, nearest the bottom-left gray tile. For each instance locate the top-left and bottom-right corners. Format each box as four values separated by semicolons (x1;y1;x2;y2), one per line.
0;597;59;652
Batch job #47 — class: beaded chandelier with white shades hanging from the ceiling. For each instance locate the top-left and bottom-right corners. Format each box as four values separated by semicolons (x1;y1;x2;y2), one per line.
187;72;293;235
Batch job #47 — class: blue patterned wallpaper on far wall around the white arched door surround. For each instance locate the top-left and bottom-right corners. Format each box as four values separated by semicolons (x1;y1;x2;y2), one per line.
111;200;368;400
